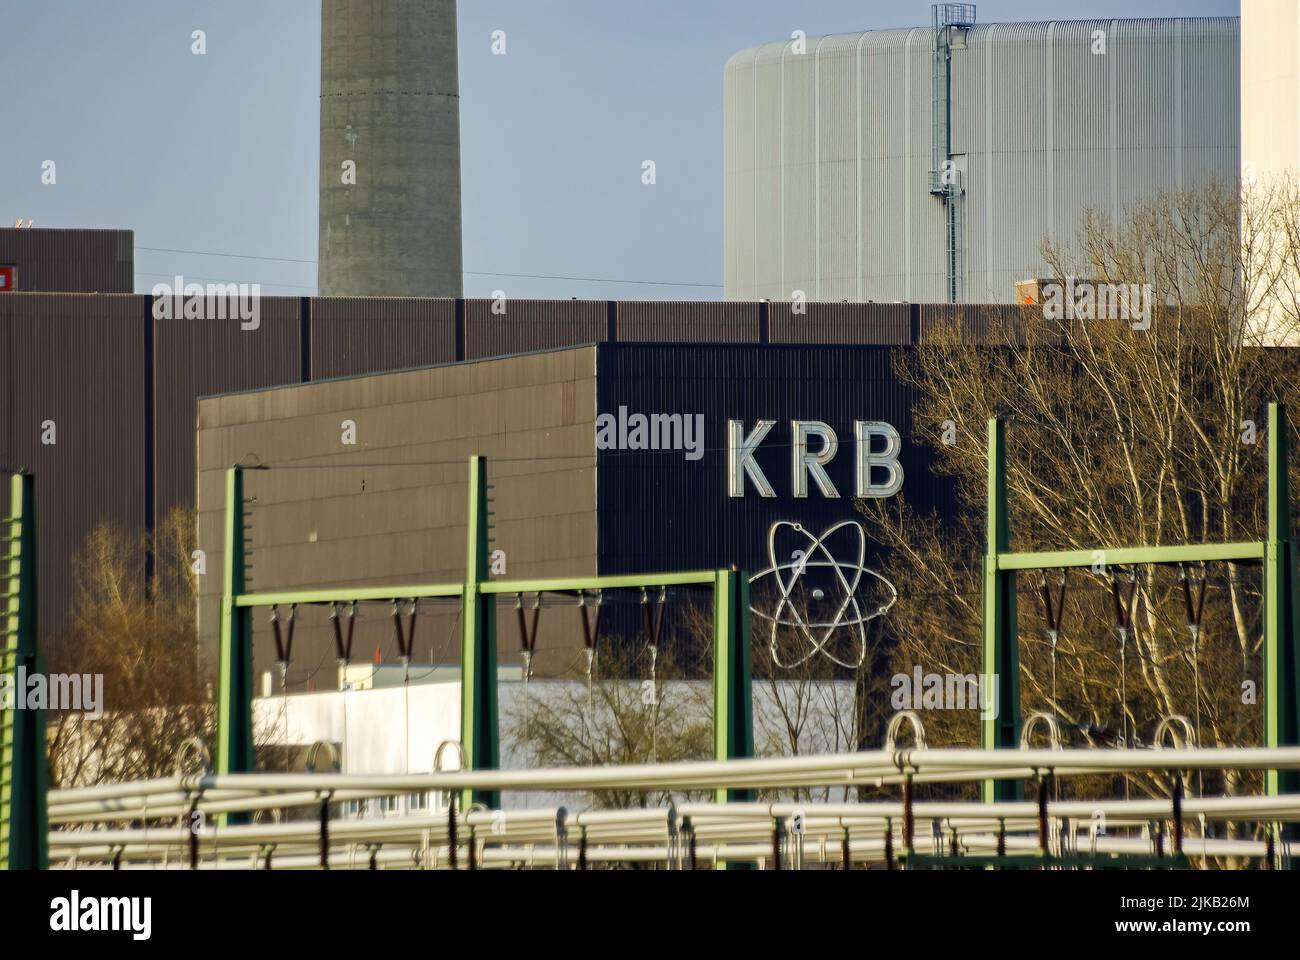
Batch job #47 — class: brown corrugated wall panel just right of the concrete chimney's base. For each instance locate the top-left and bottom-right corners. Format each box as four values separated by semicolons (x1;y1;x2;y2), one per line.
465;298;610;359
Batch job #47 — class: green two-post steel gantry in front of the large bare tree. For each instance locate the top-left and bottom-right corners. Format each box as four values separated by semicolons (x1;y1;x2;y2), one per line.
982;403;1300;800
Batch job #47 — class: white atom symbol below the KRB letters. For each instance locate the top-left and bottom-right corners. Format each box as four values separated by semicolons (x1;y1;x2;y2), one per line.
749;520;898;670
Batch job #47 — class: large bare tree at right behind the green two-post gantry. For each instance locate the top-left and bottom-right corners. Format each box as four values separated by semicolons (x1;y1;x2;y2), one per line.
861;183;1300;816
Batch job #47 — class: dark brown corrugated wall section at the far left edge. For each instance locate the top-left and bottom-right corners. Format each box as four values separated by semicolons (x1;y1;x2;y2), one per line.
0;294;146;634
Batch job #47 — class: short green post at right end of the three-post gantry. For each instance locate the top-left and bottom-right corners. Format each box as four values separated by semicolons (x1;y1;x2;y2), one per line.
714;570;754;803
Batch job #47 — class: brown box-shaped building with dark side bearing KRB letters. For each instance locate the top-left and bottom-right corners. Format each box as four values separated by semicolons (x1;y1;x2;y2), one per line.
189;341;982;689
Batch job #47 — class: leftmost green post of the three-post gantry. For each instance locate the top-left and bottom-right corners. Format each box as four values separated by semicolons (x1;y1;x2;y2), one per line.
217;467;255;785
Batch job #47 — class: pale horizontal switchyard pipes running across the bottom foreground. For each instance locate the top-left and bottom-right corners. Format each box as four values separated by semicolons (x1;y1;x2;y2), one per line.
35;741;1300;870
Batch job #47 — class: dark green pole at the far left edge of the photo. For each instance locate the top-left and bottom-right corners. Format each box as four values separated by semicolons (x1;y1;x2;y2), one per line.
0;473;49;870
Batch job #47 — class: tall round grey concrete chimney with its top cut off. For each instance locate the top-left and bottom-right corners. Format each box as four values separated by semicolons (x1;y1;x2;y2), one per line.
320;0;462;297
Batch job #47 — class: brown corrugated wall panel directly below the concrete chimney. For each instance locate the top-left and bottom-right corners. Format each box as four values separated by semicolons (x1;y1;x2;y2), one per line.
310;297;456;382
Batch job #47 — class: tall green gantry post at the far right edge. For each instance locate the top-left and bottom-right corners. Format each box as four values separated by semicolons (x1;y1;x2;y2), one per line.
1264;403;1300;795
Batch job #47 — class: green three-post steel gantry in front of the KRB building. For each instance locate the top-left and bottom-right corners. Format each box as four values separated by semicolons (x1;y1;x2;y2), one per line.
216;457;754;808
